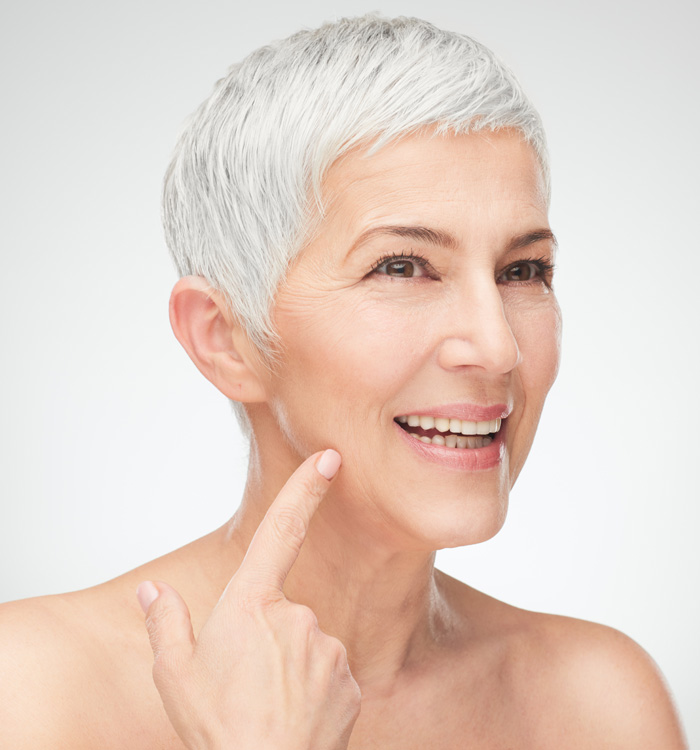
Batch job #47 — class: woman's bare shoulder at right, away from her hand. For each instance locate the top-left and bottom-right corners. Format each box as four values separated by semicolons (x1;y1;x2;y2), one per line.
438;579;687;750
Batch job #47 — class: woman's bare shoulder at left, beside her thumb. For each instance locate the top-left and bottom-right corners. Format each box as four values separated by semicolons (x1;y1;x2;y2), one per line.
0;581;183;750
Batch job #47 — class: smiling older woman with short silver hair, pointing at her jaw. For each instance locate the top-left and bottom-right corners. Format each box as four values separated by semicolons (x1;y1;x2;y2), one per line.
0;17;684;750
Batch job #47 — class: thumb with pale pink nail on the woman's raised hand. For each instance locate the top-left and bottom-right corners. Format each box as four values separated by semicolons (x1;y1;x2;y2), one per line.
136;581;195;662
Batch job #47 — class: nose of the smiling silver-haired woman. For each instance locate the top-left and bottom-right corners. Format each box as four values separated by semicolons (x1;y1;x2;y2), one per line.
438;279;520;375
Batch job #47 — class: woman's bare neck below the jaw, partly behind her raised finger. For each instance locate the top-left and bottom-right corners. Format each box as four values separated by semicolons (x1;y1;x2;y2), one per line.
225;444;450;690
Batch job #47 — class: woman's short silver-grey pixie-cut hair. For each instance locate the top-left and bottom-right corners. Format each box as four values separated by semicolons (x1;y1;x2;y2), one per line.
163;14;549;435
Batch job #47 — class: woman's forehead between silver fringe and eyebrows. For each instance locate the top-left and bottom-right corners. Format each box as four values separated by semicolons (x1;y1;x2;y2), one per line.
323;130;547;241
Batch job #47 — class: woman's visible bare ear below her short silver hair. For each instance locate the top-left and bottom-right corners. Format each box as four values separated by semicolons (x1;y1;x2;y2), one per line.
170;276;267;403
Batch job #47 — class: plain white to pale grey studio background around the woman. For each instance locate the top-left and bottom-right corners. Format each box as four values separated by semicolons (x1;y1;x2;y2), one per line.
0;0;700;746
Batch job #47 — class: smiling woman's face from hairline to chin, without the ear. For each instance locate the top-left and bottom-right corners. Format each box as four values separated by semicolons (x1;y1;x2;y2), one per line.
257;131;560;549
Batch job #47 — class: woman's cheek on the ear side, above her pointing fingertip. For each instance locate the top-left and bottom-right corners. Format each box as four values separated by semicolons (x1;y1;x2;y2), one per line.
268;295;426;465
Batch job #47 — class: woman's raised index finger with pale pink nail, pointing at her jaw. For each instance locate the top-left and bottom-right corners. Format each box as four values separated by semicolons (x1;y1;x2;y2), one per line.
230;448;341;596
